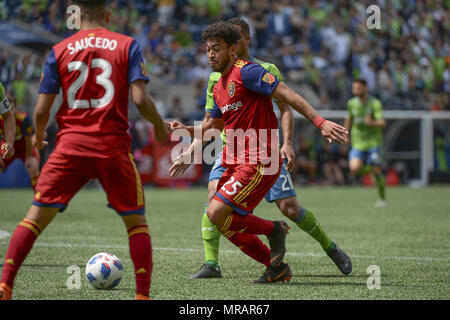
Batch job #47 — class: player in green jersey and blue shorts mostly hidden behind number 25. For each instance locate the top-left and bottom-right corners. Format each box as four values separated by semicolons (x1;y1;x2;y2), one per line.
170;18;352;278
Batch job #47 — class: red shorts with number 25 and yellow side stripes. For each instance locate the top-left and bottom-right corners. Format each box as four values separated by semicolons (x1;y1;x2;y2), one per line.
214;165;281;215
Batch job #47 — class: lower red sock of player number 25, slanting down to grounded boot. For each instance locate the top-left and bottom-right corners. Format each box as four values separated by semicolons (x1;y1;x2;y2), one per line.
228;233;270;267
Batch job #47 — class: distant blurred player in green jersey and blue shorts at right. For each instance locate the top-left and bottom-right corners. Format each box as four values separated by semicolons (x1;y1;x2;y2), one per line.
344;79;386;207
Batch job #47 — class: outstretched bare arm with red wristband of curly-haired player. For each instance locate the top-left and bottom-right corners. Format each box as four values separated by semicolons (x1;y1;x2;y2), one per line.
272;82;348;143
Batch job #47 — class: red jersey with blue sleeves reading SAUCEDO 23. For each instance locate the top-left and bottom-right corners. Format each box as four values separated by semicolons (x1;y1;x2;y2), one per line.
39;28;148;158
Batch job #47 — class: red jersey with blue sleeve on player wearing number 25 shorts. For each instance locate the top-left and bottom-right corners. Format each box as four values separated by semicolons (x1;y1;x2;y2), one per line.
211;59;281;171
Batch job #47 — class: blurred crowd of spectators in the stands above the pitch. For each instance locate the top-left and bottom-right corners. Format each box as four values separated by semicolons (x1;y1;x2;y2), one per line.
0;0;450;113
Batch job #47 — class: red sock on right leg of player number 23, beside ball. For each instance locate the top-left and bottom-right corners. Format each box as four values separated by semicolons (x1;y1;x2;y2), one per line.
128;224;153;296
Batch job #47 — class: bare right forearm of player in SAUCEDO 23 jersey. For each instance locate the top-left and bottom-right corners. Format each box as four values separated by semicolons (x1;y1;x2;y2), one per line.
131;80;169;141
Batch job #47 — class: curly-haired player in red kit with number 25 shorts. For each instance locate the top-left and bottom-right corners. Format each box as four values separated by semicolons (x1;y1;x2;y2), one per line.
172;22;347;282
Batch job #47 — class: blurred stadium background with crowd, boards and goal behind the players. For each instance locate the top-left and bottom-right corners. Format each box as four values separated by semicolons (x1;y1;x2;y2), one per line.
0;0;450;187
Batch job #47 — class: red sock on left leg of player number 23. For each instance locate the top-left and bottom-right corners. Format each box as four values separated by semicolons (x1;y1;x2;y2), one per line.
0;219;41;288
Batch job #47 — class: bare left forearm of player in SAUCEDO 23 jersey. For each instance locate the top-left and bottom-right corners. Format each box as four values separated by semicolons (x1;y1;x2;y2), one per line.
31;93;56;150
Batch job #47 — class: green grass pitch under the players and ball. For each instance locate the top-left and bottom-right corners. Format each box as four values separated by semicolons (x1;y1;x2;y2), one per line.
0;187;450;300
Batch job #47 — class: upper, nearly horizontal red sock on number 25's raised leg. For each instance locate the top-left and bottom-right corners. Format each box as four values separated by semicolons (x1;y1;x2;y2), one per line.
222;212;273;236
